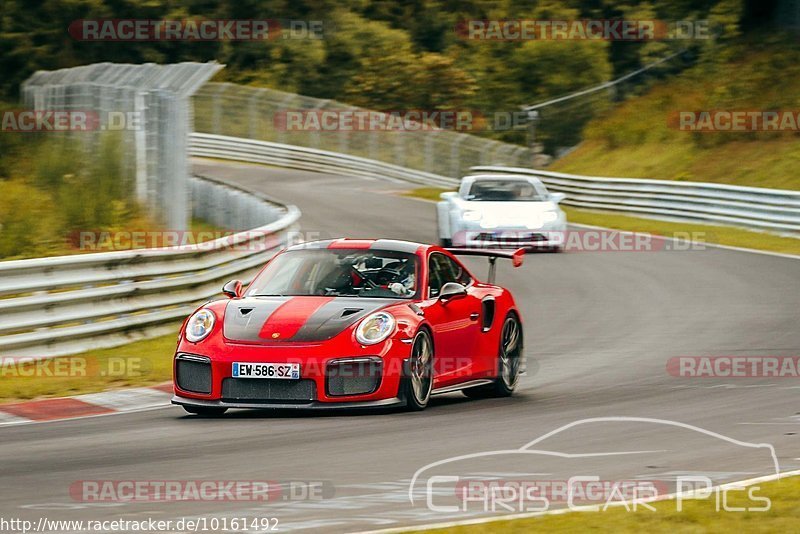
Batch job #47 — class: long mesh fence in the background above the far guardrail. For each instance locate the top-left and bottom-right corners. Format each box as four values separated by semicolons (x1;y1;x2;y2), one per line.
192;83;535;178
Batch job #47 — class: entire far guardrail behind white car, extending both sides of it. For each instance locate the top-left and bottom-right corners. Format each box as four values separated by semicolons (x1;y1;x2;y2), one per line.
189;133;800;233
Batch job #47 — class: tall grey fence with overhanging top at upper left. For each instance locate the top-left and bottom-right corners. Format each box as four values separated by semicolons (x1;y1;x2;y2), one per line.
21;62;223;230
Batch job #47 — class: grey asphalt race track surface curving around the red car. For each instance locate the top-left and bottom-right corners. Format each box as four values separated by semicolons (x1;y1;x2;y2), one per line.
0;162;800;531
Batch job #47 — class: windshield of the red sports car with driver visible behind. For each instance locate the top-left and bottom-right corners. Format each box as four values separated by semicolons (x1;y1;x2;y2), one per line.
247;249;419;298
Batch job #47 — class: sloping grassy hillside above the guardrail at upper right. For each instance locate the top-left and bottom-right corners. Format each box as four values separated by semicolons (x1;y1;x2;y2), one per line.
548;33;800;190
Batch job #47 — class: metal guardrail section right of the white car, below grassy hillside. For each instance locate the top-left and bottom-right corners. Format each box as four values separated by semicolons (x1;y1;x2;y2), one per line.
470;166;800;233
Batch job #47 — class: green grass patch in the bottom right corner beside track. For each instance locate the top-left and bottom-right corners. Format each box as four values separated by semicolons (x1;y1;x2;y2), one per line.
429;477;800;534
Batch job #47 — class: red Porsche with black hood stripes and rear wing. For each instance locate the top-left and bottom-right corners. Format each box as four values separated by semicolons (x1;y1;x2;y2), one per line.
172;239;524;416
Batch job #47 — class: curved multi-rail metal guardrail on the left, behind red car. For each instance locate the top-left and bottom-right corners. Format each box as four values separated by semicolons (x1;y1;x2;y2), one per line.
0;178;300;358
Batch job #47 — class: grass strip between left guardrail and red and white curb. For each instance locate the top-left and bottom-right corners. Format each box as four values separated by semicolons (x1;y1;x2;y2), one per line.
0;332;179;403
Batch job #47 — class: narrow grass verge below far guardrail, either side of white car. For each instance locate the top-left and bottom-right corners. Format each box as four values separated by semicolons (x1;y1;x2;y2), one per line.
404;187;800;255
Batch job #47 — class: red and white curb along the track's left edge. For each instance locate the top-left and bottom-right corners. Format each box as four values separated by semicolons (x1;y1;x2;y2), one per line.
0;383;172;427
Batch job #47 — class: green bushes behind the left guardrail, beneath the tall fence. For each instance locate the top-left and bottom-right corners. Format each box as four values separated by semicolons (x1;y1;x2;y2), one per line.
0;134;141;259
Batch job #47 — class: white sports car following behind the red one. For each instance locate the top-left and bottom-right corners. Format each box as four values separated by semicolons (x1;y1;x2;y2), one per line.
436;174;567;250
